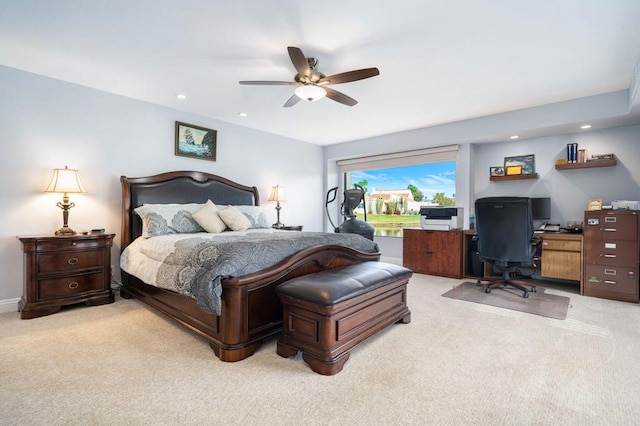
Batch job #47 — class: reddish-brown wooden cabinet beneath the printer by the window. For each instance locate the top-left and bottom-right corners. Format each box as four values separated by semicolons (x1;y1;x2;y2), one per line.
402;228;463;278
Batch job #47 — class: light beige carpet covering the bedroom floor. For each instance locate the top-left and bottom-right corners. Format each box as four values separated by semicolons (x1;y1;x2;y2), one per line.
0;275;640;425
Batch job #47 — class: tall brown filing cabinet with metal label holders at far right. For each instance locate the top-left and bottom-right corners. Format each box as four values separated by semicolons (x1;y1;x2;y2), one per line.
583;210;640;303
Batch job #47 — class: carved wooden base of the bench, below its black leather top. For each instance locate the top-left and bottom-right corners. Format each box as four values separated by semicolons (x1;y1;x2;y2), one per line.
277;262;411;376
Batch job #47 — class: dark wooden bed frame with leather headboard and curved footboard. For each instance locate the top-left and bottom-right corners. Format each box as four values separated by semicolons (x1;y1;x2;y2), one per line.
120;171;380;362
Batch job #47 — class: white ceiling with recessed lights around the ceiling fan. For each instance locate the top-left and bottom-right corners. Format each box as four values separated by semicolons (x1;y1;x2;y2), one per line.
0;0;640;145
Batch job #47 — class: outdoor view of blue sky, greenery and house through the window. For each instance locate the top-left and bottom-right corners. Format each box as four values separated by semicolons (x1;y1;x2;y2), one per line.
346;161;456;237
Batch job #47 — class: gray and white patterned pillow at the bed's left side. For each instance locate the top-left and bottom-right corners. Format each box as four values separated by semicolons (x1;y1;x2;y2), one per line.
134;203;204;238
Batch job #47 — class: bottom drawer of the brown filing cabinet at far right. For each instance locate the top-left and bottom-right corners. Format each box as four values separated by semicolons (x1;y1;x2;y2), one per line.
584;265;638;295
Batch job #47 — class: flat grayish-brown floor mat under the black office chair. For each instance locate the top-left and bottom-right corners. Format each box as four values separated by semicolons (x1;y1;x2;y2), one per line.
442;282;571;319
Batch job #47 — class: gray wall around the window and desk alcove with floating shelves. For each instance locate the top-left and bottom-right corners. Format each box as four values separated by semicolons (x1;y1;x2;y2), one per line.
324;95;640;262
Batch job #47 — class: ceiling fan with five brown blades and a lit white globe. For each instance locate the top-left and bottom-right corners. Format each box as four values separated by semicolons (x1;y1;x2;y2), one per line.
239;46;380;107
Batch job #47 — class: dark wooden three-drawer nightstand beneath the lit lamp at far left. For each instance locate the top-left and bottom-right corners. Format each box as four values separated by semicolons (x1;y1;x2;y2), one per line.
18;234;115;319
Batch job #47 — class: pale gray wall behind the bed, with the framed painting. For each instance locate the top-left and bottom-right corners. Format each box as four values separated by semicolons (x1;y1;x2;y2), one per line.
0;66;324;310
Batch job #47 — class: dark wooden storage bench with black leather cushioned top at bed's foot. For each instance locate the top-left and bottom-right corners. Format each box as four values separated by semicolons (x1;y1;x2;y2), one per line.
276;262;413;376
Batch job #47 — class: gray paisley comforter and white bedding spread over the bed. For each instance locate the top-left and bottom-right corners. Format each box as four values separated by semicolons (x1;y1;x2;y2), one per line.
120;229;379;315
